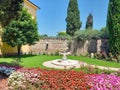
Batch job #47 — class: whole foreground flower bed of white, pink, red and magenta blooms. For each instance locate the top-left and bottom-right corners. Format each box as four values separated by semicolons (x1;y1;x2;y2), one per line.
0;65;120;90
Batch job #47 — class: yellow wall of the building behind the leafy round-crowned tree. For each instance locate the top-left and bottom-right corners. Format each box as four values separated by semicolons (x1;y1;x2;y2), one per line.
0;0;38;55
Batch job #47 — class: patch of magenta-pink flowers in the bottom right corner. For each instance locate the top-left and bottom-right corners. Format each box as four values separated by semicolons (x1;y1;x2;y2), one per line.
89;74;120;90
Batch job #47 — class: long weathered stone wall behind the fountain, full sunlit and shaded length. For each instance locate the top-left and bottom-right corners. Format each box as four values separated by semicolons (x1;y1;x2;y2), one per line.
30;39;109;55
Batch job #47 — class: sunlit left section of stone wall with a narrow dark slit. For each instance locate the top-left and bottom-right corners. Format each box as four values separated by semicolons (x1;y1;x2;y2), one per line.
30;39;68;54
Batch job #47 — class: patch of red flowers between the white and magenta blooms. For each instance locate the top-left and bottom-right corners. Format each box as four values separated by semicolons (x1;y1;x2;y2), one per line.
40;70;90;90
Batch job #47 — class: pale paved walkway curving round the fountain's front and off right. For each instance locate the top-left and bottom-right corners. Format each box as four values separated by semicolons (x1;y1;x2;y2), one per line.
43;61;120;71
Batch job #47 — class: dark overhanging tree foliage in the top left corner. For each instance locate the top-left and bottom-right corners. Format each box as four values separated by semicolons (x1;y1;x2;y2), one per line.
0;0;23;27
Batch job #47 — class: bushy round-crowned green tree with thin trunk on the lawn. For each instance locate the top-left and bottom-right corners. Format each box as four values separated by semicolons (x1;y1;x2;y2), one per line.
2;9;39;57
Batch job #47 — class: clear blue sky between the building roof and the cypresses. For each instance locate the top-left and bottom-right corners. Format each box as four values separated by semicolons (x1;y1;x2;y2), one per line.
30;0;109;36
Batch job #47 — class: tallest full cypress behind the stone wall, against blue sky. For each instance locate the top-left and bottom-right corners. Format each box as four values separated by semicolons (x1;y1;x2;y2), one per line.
66;0;82;36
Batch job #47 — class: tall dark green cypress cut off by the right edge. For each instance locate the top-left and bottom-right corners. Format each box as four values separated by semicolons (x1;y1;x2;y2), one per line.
107;0;120;58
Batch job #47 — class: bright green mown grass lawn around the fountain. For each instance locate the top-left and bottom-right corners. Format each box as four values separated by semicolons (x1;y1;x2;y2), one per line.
0;55;120;68
